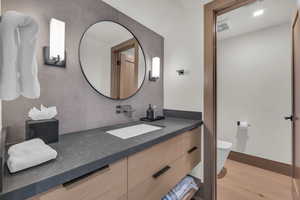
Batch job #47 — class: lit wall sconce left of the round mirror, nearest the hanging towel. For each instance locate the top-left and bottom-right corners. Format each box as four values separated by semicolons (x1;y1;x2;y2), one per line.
44;18;66;67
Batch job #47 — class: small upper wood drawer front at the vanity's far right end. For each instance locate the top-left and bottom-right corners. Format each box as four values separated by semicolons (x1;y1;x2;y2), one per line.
183;128;201;153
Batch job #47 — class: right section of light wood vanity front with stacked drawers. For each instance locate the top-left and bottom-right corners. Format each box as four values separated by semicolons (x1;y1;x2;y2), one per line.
128;128;201;200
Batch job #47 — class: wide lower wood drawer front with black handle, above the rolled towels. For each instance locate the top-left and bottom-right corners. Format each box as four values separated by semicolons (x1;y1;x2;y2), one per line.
128;156;187;200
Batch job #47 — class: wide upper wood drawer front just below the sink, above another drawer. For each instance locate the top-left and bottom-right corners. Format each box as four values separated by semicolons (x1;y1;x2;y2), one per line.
128;135;184;190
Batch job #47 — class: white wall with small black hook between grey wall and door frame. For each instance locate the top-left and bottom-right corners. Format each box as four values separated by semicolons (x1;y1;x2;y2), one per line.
164;1;204;111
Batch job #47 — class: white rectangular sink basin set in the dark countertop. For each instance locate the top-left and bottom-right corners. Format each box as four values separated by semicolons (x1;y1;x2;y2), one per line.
106;124;162;139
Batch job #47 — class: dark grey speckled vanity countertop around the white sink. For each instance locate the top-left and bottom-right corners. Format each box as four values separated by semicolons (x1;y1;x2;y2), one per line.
0;118;202;200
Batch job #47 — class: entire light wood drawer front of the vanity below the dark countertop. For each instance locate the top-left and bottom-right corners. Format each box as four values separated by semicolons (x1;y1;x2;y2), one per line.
31;128;201;200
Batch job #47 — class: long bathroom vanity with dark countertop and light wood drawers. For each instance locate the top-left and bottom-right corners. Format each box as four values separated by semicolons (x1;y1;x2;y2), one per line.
0;118;201;200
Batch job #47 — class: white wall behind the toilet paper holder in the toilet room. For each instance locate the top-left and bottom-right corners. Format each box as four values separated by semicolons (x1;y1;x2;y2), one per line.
218;24;292;163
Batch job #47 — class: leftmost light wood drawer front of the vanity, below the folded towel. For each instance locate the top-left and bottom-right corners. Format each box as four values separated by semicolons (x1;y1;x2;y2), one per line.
33;159;127;200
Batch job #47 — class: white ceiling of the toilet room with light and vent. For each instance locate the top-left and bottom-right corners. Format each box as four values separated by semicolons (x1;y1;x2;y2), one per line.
217;0;297;40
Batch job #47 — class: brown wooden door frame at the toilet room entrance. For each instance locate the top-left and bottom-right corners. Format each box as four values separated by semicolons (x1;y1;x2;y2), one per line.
203;0;256;200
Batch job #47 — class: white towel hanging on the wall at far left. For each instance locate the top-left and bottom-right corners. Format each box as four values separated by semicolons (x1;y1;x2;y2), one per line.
0;11;40;100
